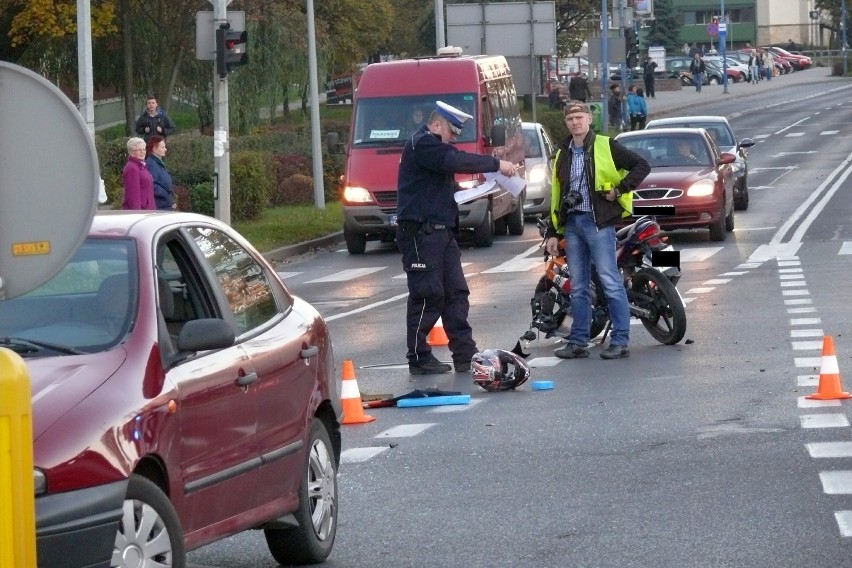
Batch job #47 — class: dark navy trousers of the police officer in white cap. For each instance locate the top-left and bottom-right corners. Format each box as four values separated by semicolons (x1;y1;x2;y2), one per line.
397;225;477;363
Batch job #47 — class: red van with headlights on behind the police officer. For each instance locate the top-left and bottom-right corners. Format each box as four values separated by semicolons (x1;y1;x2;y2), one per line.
328;48;524;254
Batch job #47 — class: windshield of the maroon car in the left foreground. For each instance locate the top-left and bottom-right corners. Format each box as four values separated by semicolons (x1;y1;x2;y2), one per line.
0;239;139;357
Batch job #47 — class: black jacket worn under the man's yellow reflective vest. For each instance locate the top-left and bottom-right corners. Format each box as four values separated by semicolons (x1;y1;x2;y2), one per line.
547;130;651;233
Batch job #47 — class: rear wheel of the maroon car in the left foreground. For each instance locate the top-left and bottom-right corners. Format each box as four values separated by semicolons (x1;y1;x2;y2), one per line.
263;418;338;565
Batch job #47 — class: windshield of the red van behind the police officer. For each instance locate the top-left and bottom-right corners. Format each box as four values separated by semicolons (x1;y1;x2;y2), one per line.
352;93;479;146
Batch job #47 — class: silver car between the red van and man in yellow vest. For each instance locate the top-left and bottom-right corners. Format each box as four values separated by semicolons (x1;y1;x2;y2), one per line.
521;122;556;216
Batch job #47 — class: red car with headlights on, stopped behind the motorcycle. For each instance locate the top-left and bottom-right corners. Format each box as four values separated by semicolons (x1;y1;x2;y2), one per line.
617;128;736;241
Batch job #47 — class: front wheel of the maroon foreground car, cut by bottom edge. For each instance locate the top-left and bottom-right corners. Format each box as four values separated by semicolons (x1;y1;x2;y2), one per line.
115;474;186;568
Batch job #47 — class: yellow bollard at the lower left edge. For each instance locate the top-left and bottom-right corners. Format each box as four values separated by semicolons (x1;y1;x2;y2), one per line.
0;348;36;568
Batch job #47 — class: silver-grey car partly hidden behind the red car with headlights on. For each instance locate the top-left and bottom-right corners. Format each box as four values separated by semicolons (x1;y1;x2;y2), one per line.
645;116;754;211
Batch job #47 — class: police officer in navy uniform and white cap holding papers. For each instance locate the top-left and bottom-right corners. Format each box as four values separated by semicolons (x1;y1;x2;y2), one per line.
396;101;515;375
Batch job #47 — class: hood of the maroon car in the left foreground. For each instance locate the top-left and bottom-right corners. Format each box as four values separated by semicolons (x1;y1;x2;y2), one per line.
24;347;127;440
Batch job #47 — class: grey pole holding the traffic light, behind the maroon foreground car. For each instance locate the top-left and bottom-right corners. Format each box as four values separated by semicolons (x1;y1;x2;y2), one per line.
210;0;231;225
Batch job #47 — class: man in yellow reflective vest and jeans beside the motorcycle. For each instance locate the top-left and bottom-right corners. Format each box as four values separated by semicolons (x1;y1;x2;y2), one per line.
545;101;651;359
